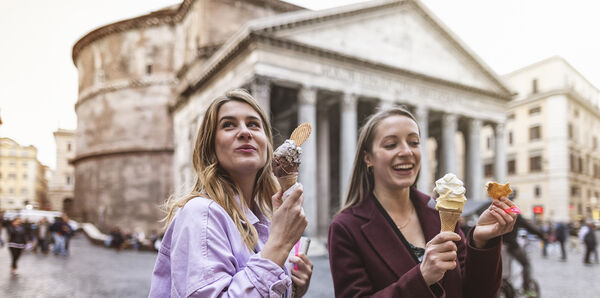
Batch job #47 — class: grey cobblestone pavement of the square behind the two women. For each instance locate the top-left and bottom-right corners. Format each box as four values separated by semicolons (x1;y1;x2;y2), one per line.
0;235;600;298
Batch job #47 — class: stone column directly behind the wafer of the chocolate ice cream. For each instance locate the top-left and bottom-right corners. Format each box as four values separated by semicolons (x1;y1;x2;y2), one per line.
298;87;318;236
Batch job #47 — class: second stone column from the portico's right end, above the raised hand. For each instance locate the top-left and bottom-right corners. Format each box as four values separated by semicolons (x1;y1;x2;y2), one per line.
466;119;486;199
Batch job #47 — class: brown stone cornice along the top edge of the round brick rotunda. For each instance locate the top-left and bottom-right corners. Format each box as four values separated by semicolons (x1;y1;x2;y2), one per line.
71;0;304;64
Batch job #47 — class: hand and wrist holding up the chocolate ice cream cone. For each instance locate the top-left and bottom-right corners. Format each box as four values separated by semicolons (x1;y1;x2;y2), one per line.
261;184;308;266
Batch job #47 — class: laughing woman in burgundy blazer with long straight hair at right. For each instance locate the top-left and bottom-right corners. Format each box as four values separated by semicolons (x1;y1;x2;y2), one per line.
329;107;515;297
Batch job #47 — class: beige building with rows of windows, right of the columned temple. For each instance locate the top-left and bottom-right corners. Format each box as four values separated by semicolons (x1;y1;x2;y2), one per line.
482;57;600;221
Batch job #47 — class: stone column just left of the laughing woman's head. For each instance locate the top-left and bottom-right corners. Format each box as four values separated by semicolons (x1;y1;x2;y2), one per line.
340;93;358;204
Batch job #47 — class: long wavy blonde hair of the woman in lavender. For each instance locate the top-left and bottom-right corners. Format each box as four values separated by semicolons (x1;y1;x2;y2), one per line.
164;89;278;250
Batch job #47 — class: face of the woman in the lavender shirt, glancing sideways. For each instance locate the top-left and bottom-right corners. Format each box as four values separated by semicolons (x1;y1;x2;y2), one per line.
215;100;267;177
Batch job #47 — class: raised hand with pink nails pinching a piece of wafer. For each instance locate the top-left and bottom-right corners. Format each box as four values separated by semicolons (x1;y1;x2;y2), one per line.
473;197;517;248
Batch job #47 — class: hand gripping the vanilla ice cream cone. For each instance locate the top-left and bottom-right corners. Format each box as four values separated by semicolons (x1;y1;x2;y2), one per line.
420;232;460;286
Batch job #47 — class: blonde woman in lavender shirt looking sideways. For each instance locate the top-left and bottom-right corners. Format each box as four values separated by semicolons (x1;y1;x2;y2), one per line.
149;90;313;297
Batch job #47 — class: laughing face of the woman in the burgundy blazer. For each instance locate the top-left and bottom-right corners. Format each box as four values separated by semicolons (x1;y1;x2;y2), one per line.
365;115;421;189
